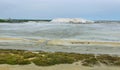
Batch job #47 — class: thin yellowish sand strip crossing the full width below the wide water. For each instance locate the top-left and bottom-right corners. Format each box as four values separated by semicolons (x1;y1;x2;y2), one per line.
0;38;120;46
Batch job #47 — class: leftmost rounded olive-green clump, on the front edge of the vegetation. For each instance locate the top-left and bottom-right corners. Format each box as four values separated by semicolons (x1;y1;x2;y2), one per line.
0;54;30;65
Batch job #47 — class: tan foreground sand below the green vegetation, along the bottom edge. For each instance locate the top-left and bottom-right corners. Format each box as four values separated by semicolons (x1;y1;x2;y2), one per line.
0;63;120;70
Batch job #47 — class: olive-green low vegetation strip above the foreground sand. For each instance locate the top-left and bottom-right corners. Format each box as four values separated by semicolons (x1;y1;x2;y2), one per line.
0;50;120;66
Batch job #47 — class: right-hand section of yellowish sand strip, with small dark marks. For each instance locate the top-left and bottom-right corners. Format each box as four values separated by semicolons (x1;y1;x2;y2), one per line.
48;40;120;46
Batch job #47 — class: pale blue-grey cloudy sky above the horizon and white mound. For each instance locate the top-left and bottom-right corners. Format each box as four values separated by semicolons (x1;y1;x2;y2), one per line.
0;0;120;20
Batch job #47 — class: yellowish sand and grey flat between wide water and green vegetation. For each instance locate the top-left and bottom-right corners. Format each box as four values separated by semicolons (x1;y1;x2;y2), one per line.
0;38;120;55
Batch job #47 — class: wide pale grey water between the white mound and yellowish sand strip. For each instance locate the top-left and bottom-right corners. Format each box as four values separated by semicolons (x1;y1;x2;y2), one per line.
0;23;120;41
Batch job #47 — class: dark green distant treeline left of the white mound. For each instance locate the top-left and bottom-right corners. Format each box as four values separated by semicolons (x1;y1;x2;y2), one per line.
0;19;51;23
